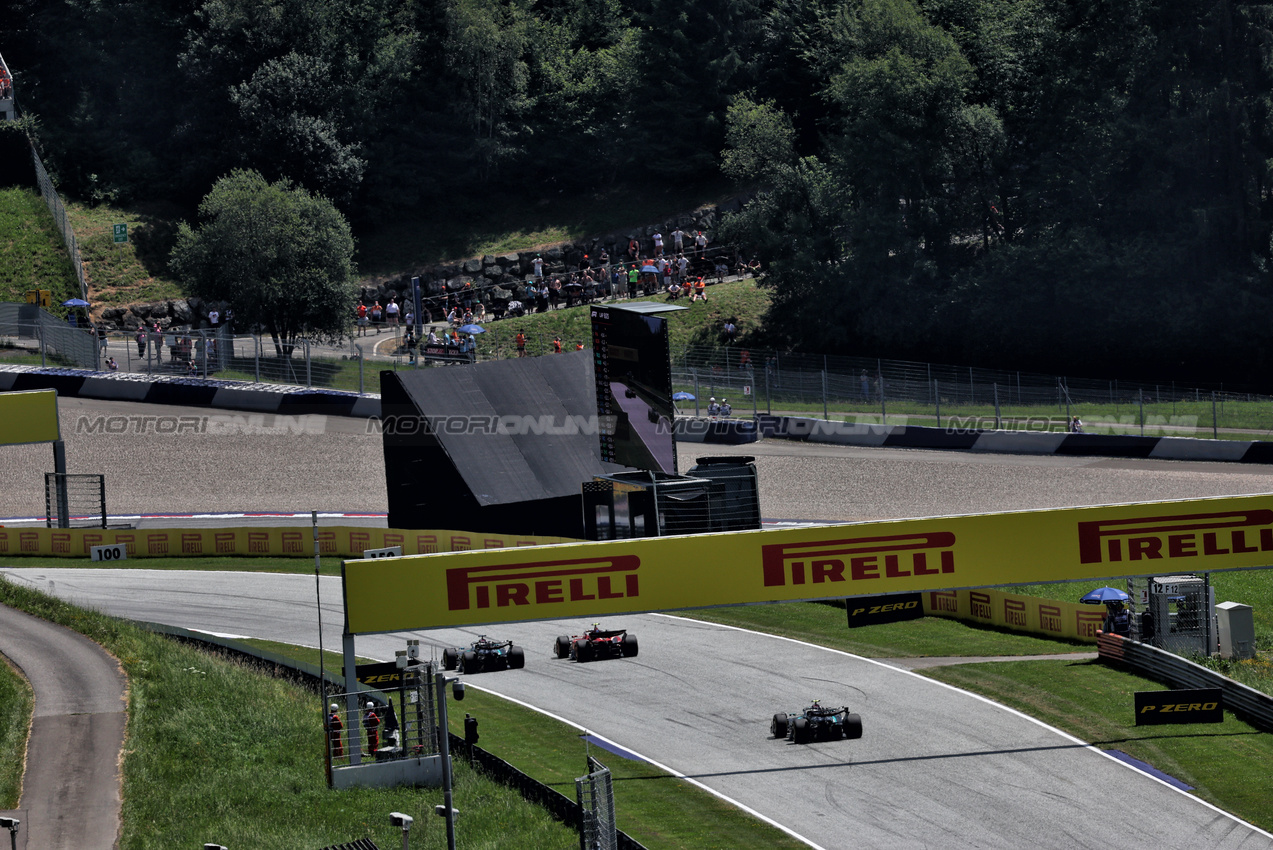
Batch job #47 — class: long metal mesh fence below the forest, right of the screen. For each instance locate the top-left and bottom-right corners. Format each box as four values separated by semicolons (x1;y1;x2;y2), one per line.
672;346;1273;439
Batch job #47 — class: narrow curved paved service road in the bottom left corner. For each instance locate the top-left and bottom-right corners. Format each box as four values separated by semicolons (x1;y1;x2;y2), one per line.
0;606;127;850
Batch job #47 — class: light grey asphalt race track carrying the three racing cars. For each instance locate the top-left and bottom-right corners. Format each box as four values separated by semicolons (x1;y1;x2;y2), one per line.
4;569;1273;850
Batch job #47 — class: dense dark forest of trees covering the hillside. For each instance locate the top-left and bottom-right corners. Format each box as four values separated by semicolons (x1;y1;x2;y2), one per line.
7;0;1273;388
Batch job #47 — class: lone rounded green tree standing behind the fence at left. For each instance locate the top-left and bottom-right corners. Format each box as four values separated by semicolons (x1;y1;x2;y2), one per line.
171;171;356;356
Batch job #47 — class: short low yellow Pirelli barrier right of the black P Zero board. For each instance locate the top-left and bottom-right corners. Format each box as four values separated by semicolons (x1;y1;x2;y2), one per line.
924;588;1105;644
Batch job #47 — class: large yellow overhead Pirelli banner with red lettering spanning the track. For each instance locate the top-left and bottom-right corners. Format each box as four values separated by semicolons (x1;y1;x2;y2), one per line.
344;495;1273;634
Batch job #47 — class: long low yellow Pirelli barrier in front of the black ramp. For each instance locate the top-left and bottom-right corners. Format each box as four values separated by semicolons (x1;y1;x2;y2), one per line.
0;526;566;557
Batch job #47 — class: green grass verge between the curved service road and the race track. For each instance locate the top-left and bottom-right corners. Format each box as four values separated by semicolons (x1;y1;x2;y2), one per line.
0;582;578;850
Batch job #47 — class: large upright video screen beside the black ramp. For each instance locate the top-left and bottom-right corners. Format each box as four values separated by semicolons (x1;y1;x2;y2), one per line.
592;304;676;475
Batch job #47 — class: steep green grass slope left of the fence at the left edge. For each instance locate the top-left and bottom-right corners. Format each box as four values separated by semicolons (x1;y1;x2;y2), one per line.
0;188;79;304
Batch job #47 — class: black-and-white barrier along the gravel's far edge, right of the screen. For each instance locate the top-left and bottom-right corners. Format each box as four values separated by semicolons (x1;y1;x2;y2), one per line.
756;414;1273;463
